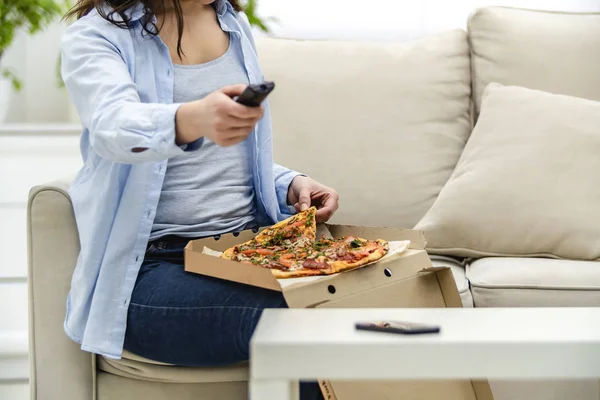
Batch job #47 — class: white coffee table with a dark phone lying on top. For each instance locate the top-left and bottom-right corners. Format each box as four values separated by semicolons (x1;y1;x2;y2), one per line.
250;308;600;400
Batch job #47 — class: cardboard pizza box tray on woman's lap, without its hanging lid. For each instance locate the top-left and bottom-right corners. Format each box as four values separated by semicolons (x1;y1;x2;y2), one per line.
184;225;460;307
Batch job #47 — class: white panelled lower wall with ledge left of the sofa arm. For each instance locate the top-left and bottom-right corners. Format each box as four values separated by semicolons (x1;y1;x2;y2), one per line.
0;125;81;384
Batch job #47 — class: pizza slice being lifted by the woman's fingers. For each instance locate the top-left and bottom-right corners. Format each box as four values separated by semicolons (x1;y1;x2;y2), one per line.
221;207;317;261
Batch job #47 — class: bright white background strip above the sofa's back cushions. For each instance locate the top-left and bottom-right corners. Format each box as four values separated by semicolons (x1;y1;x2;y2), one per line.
259;0;600;40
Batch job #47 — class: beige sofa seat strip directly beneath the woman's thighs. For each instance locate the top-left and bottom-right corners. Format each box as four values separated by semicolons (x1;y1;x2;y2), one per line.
98;351;248;383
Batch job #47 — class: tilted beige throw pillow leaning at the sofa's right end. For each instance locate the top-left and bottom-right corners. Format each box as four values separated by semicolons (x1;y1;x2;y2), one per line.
416;83;600;260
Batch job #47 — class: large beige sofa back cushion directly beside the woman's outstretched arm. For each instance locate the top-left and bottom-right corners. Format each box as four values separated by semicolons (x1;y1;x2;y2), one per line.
258;30;471;228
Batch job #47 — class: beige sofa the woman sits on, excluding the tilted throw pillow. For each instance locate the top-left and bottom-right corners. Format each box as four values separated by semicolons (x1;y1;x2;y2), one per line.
28;8;600;400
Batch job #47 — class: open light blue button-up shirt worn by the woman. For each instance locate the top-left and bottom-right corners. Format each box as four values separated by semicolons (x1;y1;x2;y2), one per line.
62;0;297;358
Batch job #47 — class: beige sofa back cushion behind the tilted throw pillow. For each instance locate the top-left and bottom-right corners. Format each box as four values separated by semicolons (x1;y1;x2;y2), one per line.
468;7;600;112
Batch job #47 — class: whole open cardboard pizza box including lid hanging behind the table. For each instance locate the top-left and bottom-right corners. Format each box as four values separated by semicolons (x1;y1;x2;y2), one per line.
185;225;493;400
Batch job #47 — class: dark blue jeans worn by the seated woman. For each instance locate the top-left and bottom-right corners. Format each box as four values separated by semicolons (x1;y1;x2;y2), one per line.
124;237;323;400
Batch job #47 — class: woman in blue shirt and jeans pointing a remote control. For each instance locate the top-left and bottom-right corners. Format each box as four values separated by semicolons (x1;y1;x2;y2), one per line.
62;0;338;398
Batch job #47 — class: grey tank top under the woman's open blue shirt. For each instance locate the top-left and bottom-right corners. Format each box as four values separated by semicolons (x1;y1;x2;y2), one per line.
150;35;256;240
